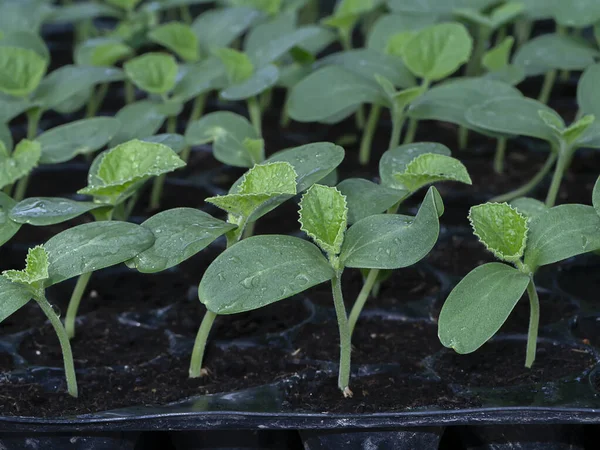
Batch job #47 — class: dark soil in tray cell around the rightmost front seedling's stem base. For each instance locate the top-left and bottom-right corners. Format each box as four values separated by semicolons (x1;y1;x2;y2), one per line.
433;339;598;388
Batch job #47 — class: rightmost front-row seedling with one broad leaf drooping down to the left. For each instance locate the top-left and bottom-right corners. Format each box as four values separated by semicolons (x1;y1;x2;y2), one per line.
439;203;600;368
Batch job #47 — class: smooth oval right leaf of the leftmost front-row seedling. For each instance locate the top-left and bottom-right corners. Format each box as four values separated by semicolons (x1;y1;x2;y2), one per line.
44;220;154;286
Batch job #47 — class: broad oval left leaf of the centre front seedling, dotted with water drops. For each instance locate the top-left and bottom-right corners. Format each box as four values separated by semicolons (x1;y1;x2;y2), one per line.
198;235;333;314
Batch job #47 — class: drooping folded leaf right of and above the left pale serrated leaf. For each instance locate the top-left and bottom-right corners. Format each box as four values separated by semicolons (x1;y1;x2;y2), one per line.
185;111;264;167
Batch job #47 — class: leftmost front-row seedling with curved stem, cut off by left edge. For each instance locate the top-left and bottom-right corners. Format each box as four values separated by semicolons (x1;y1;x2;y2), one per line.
0;222;154;397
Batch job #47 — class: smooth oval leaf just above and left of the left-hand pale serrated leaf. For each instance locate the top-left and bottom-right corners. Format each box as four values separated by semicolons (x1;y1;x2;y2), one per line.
37;117;121;164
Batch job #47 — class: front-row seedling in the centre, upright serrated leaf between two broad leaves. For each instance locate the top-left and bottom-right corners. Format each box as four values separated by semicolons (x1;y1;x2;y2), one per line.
198;184;443;397
